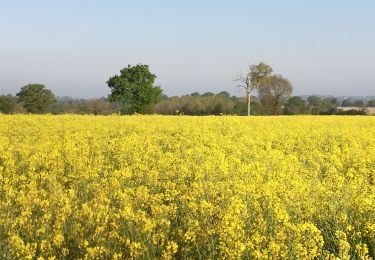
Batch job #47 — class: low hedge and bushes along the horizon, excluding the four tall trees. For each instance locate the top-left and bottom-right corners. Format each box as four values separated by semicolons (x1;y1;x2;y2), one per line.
0;91;375;115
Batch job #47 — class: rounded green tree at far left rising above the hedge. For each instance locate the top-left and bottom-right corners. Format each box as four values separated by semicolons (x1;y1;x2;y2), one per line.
16;84;56;114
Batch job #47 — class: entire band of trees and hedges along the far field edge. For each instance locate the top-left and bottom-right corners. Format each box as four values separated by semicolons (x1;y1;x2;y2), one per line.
0;63;375;115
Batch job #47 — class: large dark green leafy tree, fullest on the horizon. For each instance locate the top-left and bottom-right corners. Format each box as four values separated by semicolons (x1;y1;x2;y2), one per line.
107;64;162;113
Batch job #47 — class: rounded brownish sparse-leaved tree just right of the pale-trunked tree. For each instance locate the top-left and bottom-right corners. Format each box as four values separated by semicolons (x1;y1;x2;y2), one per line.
259;75;293;115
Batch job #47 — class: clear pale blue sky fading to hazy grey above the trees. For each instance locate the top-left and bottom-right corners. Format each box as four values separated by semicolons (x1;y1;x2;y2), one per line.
0;0;375;97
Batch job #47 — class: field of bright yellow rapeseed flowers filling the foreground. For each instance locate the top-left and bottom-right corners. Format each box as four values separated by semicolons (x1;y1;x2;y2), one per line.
0;115;375;259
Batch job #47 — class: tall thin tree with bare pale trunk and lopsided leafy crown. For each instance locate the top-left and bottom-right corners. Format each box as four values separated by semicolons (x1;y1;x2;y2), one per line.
236;62;272;116
